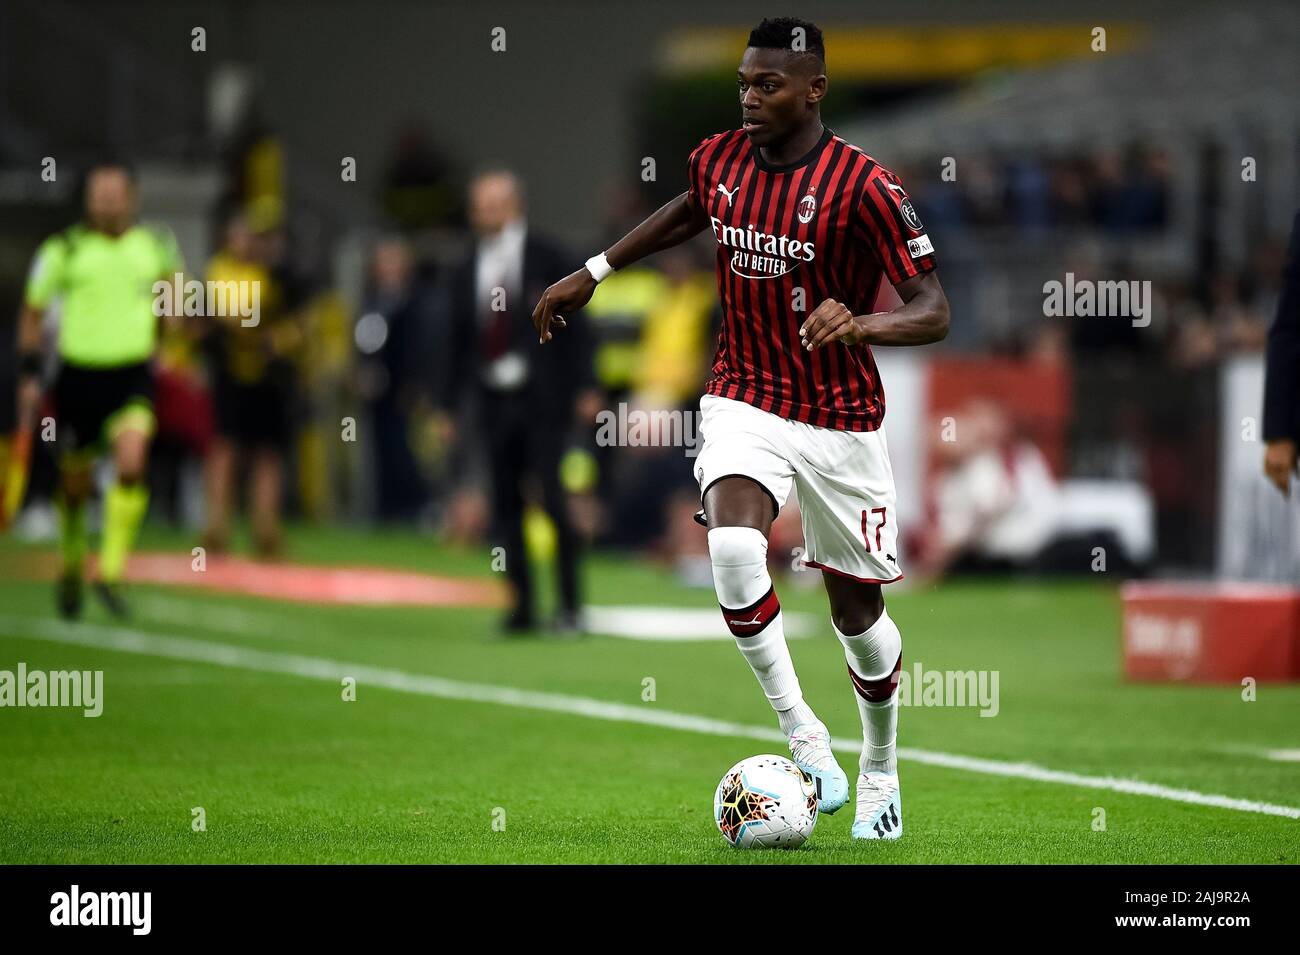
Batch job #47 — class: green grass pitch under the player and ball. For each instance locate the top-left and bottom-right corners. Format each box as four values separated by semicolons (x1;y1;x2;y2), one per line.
0;529;1300;864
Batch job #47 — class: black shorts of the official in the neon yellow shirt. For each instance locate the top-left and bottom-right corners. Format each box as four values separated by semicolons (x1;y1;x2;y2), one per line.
55;361;153;453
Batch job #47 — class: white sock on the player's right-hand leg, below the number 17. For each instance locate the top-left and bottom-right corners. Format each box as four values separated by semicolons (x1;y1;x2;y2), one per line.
831;611;902;773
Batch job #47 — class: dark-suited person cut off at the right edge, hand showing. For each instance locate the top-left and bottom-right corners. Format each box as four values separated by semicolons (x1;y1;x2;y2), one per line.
1264;213;1300;496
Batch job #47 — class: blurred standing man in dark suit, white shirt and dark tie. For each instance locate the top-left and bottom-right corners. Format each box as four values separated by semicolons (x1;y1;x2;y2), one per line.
445;170;599;631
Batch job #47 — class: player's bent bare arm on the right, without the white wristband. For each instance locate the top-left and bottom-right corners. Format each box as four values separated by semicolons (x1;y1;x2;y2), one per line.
800;272;948;351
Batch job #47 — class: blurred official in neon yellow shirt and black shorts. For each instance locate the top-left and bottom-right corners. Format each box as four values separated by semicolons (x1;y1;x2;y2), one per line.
18;164;183;617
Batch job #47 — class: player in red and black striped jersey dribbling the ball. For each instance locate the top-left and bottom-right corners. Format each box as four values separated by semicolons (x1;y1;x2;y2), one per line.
533;18;948;839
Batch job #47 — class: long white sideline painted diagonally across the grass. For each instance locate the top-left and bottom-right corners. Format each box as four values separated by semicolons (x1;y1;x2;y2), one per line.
0;616;1300;819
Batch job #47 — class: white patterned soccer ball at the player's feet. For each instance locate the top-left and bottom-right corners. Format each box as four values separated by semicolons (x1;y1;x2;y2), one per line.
714;755;816;848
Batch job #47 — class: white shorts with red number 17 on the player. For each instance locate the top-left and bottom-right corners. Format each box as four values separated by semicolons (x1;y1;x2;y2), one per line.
696;395;902;583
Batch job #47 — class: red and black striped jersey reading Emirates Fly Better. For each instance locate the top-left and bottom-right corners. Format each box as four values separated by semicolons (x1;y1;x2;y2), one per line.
686;129;936;431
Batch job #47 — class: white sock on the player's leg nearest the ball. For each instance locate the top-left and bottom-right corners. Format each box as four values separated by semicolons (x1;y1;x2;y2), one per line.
709;528;816;735
